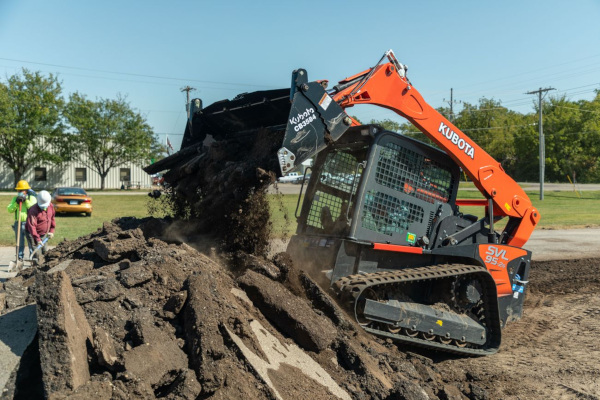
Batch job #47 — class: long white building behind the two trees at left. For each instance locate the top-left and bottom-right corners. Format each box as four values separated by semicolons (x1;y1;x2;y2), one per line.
0;161;152;190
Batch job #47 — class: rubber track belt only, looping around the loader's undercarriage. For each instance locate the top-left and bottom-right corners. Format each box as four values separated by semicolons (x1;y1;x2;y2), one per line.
333;264;501;356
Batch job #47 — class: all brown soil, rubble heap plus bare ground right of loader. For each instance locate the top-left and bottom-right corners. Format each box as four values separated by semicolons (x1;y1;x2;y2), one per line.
2;219;600;399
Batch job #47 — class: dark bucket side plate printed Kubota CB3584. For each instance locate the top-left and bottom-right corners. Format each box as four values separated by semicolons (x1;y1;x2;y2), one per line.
277;69;351;175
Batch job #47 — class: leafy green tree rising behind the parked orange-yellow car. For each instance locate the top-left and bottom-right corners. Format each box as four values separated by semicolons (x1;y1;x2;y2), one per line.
65;93;156;189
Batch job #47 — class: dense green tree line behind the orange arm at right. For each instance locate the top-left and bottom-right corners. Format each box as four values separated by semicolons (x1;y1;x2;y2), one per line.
371;92;600;183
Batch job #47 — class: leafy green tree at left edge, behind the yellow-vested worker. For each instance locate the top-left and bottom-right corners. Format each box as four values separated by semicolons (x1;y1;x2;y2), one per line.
0;69;69;184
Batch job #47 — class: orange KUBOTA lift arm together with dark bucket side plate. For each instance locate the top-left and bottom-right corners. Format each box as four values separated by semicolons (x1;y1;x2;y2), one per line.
278;50;540;247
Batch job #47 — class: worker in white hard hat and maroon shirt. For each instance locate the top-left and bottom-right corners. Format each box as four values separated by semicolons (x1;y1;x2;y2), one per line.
25;190;56;260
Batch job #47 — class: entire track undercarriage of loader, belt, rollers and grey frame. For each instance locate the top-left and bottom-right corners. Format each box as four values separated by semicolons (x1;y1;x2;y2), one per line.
333;264;501;356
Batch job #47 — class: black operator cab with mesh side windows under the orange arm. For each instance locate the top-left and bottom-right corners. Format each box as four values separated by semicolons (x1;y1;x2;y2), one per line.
297;125;460;246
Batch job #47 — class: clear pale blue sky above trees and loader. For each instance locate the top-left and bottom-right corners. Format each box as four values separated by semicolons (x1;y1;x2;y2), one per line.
0;0;600;148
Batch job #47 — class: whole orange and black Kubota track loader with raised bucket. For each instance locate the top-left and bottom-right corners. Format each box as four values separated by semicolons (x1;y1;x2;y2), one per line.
149;51;540;355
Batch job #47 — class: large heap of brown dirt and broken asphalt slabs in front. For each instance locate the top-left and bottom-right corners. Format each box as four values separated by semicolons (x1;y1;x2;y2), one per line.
4;219;492;399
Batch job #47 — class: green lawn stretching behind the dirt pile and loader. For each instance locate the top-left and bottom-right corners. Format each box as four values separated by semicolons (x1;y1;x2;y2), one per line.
0;191;600;246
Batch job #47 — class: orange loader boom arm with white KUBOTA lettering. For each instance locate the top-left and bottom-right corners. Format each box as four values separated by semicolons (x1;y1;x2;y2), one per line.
284;50;540;247
